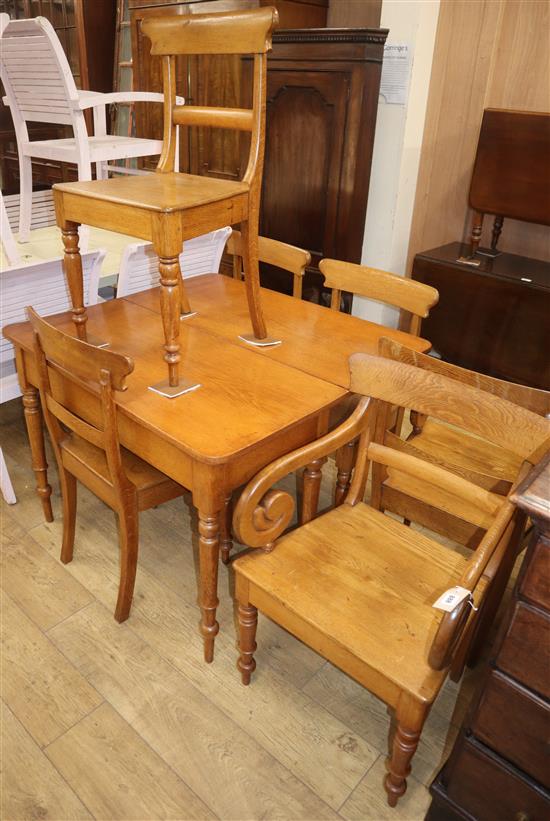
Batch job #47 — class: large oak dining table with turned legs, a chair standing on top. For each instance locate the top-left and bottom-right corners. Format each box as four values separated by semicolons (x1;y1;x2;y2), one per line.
4;274;429;661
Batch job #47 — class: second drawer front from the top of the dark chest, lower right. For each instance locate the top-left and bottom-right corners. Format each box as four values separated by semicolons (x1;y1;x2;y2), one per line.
496;602;550;699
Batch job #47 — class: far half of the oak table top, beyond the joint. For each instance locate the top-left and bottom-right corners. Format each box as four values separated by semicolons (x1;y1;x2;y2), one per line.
125;274;431;389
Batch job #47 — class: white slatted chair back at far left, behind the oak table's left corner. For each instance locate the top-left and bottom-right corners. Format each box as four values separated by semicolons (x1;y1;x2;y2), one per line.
0;250;105;362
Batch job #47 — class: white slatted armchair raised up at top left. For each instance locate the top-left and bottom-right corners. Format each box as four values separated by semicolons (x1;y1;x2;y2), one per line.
0;14;183;247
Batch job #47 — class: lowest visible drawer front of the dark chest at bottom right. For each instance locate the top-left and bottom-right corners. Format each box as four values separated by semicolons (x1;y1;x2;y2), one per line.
447;739;550;821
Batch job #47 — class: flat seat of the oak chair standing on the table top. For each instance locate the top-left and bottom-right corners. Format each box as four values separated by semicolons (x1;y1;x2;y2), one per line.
55;172;249;211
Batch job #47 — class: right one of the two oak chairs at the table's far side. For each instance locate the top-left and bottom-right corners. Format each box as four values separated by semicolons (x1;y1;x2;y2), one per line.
319;259;439;504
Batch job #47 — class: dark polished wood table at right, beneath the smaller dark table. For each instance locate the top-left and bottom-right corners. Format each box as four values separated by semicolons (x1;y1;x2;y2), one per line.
412;242;550;390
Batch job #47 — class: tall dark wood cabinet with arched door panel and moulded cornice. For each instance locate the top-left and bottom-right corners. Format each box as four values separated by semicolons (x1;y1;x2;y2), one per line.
260;28;387;300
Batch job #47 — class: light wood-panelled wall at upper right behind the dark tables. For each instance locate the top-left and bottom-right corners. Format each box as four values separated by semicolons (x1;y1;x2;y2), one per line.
407;0;550;270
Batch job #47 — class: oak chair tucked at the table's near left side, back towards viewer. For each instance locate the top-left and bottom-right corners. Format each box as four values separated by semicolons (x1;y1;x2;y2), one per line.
27;308;185;622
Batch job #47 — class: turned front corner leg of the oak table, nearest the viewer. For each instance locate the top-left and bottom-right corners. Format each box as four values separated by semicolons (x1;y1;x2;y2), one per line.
199;510;220;662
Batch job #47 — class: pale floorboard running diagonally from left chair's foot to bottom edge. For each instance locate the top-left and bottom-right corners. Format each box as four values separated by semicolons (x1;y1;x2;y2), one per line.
49;604;336;820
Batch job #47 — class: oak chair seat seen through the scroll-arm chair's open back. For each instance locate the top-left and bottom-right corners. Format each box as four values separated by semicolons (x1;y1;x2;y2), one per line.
410;419;522;486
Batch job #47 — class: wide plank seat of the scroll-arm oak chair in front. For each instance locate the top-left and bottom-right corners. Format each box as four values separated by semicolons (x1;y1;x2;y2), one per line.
234;503;474;702
